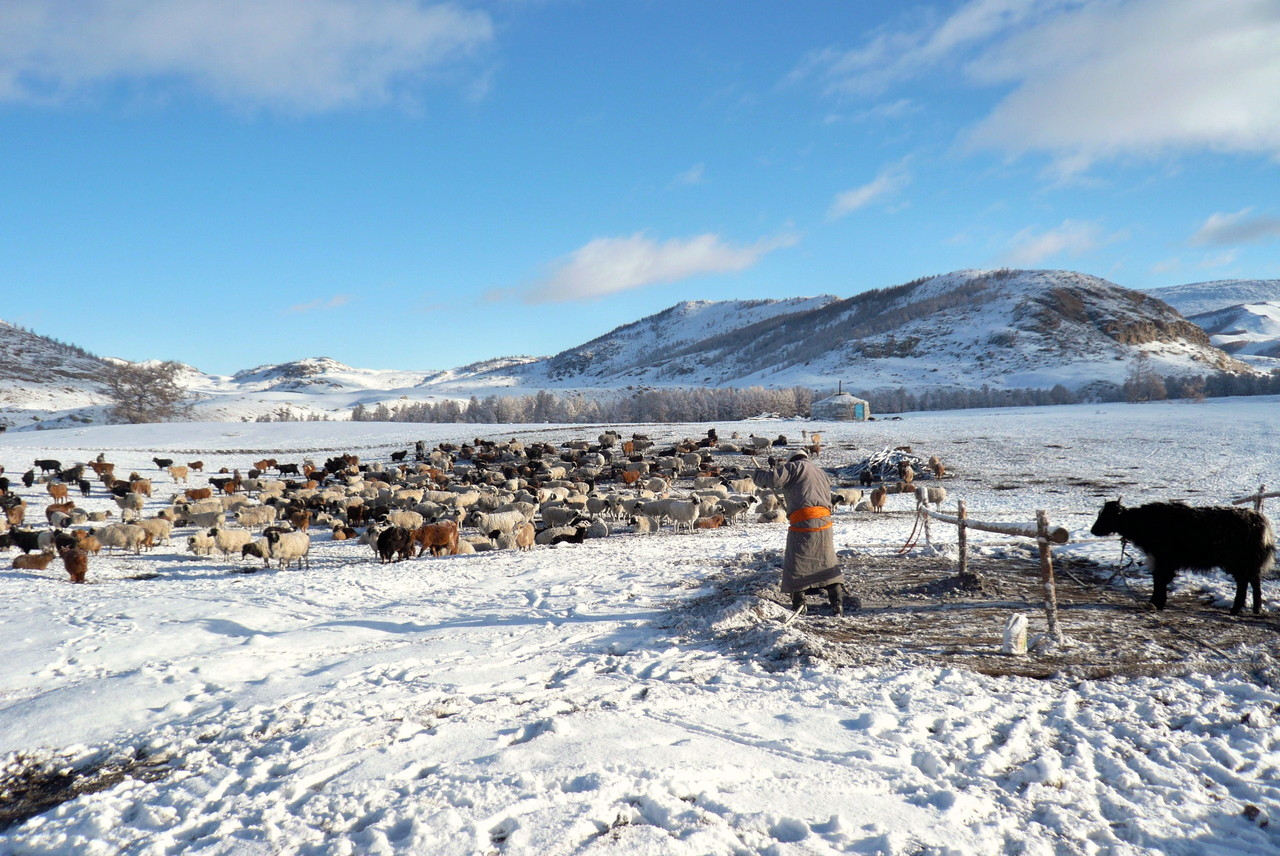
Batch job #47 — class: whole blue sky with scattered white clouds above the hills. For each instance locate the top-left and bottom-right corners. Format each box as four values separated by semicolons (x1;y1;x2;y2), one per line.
0;0;1280;374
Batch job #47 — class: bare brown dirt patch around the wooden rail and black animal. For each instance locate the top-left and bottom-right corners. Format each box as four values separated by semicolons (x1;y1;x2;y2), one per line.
675;548;1280;678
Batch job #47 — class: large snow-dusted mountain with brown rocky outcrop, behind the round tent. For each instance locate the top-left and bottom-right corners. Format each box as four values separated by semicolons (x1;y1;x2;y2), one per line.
463;270;1248;389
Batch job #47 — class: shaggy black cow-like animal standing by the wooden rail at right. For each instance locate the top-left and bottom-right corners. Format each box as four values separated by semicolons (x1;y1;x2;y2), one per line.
1089;500;1276;615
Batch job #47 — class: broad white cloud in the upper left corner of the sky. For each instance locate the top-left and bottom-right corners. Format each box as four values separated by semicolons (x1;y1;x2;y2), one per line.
0;0;493;111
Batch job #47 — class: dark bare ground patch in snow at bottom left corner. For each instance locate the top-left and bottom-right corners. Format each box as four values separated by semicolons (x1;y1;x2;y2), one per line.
0;750;174;832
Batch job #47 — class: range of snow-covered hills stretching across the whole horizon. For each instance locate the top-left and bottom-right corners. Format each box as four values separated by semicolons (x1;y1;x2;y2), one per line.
0;270;1259;425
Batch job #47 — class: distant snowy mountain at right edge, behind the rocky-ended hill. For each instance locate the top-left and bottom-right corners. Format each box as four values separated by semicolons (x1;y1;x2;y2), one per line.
1147;279;1280;367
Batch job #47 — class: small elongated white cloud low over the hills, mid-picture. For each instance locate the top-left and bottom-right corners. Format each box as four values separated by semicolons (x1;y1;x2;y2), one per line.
524;233;797;303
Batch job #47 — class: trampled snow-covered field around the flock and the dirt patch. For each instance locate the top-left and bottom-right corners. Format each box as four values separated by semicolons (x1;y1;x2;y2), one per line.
0;398;1280;856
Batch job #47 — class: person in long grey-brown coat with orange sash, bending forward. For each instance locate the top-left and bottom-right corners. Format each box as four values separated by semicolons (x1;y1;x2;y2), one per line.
751;452;845;615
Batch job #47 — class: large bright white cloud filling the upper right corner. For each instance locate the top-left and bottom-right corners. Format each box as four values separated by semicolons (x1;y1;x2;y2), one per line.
794;0;1280;173
